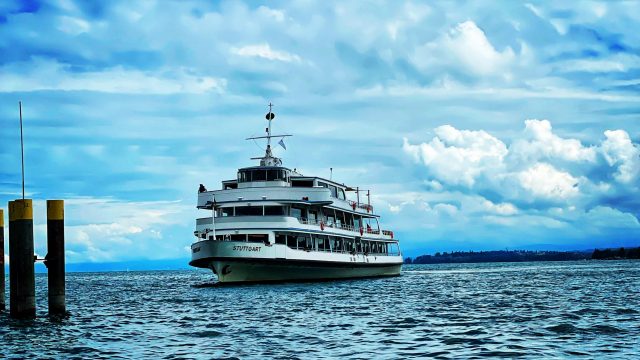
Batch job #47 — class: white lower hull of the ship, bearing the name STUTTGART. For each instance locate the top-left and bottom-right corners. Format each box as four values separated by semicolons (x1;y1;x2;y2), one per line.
191;241;402;283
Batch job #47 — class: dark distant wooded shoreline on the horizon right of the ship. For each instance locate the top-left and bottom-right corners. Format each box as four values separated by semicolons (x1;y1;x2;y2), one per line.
404;247;640;264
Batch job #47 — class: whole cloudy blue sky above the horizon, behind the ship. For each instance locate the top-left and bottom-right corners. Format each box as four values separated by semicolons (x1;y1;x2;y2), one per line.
0;0;640;264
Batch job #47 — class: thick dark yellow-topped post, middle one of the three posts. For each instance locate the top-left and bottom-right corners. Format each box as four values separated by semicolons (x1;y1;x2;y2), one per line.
9;199;36;319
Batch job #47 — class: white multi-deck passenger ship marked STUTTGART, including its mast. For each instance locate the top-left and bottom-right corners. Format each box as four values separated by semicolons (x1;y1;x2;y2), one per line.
189;104;402;283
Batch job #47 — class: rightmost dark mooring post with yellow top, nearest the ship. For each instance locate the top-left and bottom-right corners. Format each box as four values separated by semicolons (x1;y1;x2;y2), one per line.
45;200;66;315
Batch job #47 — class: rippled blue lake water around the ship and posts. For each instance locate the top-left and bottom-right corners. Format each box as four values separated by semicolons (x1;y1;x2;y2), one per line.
0;261;640;359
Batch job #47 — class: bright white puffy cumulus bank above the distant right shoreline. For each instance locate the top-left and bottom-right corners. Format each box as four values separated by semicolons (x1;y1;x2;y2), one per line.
402;120;640;212
